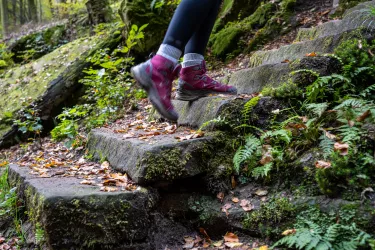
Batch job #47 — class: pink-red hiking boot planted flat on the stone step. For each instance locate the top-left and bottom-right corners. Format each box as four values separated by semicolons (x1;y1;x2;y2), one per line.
176;61;237;101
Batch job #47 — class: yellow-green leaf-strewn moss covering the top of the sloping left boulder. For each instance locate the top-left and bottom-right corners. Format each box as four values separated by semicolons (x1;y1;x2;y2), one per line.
0;36;107;138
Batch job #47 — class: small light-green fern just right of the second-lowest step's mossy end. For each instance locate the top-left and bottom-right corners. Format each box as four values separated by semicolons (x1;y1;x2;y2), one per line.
233;135;262;173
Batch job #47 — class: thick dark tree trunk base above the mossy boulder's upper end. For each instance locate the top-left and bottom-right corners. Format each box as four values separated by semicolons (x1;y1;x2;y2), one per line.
86;0;111;26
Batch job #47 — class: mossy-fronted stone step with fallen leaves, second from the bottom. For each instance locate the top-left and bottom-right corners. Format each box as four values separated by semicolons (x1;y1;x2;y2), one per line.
87;129;232;185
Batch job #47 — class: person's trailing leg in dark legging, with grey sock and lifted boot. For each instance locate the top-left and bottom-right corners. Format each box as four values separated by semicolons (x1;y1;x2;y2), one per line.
131;0;217;120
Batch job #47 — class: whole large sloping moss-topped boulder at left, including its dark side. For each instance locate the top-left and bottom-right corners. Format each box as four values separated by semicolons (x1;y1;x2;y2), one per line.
0;32;119;147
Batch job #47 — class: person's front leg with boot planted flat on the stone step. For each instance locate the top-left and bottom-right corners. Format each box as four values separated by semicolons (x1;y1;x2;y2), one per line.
177;0;237;101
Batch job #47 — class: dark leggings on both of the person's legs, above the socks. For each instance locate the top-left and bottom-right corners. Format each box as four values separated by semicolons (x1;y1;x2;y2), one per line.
163;0;222;55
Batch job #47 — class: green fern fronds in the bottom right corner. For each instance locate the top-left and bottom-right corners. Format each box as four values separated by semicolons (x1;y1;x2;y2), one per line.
273;208;371;250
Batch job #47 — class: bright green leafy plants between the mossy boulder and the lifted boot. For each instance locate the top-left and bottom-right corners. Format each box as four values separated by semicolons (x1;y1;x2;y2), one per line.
51;25;147;141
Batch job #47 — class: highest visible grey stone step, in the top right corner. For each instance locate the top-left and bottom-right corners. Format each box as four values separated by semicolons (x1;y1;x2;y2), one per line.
295;1;375;42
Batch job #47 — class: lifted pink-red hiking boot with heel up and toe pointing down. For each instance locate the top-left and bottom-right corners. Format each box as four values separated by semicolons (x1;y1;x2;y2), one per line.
131;55;181;121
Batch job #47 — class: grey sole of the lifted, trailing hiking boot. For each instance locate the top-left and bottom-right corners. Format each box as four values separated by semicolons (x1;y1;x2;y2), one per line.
130;66;178;121
